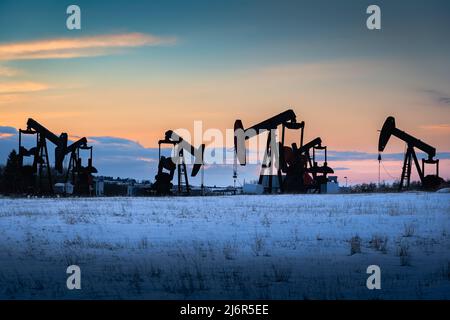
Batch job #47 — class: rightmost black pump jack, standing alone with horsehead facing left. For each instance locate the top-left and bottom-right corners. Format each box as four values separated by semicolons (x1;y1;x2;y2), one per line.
378;117;444;191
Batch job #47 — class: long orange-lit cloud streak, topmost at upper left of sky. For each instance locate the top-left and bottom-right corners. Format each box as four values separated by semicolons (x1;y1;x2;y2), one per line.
0;33;176;60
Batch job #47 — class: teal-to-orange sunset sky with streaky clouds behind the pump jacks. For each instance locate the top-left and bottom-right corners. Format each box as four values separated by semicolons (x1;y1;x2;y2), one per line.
0;0;450;183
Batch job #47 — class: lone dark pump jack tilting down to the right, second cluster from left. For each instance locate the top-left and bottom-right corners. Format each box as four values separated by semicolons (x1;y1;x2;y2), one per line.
153;130;205;195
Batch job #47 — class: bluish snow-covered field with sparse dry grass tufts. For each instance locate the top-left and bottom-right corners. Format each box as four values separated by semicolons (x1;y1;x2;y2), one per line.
0;193;450;299
